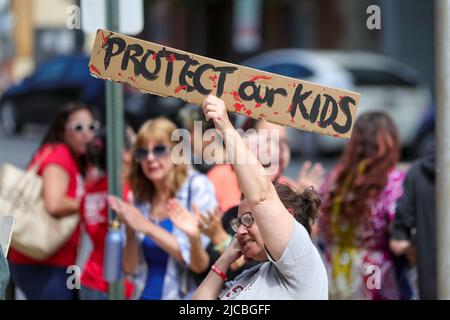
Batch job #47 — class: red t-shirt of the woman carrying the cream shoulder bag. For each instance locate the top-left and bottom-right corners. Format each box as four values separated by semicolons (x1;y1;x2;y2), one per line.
9;143;84;267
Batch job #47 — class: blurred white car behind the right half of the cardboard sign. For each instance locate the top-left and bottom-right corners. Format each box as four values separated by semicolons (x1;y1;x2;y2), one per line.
243;49;431;155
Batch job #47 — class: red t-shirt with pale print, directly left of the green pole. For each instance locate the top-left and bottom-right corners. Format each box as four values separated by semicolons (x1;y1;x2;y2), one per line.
80;177;132;298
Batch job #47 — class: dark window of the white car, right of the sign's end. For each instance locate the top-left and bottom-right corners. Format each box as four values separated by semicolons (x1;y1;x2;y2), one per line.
348;69;417;88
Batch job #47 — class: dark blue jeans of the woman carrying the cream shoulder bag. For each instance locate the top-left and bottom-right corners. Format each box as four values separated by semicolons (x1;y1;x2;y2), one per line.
10;263;79;300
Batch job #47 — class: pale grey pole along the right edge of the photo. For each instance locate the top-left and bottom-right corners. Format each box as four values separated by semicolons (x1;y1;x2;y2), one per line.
435;0;450;300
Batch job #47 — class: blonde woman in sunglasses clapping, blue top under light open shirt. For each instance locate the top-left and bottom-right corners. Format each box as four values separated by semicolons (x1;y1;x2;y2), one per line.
109;118;216;300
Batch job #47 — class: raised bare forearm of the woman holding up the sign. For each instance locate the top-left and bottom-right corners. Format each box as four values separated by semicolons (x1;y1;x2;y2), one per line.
223;126;275;205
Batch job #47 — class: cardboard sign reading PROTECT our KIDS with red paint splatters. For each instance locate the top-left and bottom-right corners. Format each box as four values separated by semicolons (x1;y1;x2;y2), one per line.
89;30;359;138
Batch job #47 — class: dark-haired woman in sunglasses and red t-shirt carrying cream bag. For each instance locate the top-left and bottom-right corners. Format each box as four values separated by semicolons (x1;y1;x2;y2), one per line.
9;103;98;300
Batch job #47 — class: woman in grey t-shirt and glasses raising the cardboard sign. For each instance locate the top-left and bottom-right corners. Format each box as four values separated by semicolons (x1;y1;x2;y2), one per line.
194;95;328;299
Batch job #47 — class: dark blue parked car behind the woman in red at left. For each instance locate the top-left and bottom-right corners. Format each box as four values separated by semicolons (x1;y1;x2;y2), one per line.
0;54;182;135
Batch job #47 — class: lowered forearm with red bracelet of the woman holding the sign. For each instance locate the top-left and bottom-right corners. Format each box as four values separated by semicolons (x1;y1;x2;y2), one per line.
193;256;230;300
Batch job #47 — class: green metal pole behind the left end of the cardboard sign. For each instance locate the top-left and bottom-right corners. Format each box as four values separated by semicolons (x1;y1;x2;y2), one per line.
105;0;124;300
